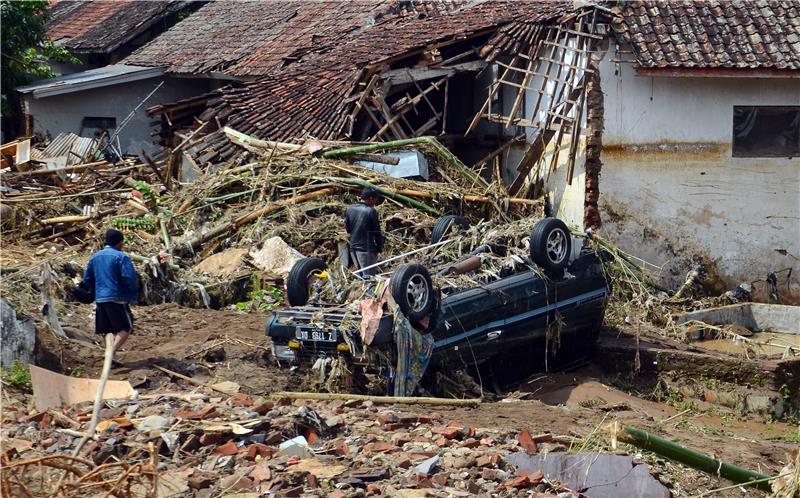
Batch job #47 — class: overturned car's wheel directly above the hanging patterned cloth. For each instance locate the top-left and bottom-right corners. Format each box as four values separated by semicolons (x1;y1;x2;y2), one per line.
389;264;436;323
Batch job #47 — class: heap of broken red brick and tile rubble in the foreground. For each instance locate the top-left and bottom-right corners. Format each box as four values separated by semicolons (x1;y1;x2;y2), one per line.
2;391;668;497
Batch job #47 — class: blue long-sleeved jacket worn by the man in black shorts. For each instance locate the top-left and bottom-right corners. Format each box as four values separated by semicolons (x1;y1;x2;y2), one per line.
83;246;139;304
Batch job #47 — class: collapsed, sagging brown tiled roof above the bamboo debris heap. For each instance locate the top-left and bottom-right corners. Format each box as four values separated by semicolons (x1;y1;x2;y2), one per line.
180;1;563;160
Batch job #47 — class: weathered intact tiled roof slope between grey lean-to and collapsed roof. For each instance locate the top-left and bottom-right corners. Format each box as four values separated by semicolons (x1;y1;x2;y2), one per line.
126;0;472;76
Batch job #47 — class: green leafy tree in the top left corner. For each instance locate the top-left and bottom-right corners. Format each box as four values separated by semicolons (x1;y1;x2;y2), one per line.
0;0;78;126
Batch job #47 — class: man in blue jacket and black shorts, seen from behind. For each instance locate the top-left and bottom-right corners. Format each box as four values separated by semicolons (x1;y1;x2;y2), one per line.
83;229;139;366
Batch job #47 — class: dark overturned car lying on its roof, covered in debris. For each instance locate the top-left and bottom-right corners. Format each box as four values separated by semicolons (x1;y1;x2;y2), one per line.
266;216;609;395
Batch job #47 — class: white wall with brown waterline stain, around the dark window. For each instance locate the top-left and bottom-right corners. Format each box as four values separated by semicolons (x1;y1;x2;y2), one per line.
600;40;800;302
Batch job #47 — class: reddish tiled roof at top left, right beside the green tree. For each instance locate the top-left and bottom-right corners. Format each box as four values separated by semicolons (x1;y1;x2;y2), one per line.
47;0;187;53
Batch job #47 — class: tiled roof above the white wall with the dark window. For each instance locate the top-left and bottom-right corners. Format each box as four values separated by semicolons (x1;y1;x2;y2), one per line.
614;0;800;69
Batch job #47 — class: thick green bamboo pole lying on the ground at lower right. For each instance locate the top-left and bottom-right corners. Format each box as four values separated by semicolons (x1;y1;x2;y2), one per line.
606;422;771;492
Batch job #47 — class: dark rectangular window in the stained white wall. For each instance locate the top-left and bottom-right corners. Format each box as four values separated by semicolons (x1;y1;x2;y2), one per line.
733;106;800;157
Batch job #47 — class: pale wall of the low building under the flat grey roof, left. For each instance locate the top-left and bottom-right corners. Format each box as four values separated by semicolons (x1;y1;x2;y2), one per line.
25;77;209;154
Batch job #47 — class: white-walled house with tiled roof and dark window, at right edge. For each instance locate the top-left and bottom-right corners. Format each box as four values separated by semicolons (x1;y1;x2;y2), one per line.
600;0;800;303
